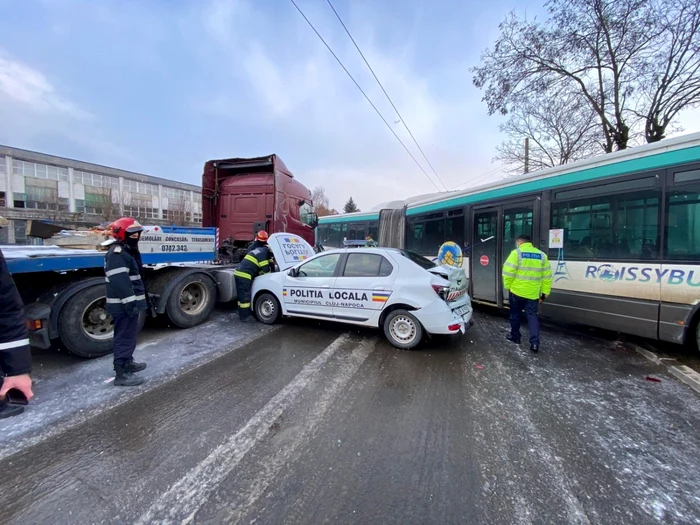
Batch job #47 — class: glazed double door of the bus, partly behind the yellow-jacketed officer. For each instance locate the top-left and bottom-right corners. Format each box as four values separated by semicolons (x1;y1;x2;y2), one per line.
470;201;535;306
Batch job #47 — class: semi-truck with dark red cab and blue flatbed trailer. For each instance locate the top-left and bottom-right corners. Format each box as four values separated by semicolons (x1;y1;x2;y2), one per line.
0;155;317;358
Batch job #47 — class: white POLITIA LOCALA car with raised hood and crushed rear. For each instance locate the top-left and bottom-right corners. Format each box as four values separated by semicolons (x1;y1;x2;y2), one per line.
252;233;472;348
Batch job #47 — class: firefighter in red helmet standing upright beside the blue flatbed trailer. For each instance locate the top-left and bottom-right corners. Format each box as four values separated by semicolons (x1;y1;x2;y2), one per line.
104;217;148;386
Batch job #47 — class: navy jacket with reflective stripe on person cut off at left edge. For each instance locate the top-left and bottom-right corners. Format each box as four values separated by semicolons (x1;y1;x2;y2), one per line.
0;251;32;376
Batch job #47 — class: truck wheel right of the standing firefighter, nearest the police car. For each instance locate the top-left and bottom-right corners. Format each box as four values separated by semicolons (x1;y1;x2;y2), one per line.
165;273;216;328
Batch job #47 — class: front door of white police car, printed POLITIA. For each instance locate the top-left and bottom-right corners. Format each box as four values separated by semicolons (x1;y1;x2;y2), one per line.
282;253;341;319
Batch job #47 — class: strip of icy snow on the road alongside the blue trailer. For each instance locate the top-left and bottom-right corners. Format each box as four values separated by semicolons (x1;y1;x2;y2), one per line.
0;312;277;459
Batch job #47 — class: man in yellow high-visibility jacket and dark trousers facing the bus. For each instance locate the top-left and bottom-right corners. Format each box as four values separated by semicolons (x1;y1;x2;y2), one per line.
503;235;552;352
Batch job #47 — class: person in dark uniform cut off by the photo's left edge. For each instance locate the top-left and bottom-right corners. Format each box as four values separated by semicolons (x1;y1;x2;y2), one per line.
0;217;34;419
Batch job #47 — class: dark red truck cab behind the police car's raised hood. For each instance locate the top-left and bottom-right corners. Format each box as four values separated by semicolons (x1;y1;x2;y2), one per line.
202;155;318;258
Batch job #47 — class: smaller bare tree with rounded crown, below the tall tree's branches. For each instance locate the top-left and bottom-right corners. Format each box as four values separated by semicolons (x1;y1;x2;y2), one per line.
494;89;600;175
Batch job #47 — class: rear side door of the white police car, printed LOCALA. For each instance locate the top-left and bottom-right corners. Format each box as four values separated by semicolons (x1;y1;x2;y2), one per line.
330;250;398;325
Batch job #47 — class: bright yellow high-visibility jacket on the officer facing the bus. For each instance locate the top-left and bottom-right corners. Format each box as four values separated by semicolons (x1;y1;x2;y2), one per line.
503;242;552;299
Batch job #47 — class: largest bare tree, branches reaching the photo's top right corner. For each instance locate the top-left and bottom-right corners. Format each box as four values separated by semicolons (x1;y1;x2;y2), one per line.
472;0;700;152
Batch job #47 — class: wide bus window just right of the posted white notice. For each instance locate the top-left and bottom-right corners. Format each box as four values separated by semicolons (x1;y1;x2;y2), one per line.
550;190;659;260
